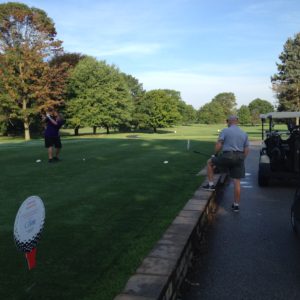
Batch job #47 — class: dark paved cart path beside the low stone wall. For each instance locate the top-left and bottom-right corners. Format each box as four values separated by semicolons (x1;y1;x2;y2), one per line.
182;146;300;300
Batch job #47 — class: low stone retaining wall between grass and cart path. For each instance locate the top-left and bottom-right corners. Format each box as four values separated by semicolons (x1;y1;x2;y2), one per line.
114;174;226;300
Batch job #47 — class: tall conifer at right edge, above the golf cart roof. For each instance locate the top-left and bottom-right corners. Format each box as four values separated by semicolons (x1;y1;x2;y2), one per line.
271;33;300;111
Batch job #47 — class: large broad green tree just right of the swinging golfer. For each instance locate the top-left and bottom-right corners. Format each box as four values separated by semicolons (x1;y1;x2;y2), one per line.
67;57;133;134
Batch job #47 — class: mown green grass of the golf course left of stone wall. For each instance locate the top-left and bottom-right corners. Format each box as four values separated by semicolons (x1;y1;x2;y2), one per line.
0;125;256;300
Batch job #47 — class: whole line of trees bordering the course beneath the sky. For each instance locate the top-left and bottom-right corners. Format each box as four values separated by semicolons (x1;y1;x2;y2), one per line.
0;2;300;140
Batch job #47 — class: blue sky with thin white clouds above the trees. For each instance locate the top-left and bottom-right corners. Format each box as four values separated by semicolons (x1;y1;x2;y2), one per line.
5;0;300;109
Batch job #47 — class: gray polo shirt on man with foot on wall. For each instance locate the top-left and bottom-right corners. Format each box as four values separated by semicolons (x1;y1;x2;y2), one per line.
218;125;249;152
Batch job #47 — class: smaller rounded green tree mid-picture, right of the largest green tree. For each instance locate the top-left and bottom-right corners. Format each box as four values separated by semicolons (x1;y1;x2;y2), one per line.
138;89;180;132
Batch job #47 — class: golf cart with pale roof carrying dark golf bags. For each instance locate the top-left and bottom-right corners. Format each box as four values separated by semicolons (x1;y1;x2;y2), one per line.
258;112;300;186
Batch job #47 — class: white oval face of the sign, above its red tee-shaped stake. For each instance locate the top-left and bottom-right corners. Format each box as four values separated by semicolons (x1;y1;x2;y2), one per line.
14;196;45;252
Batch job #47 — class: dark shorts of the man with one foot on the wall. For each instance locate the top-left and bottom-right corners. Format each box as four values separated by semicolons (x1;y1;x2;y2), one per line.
211;152;245;179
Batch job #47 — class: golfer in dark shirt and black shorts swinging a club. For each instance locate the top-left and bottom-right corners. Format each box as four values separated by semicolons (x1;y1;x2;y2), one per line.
44;108;64;163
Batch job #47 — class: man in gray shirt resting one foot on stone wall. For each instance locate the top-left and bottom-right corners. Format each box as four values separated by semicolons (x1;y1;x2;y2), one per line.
202;115;249;212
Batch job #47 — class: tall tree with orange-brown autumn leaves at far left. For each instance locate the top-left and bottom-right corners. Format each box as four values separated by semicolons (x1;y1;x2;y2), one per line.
0;2;66;140
